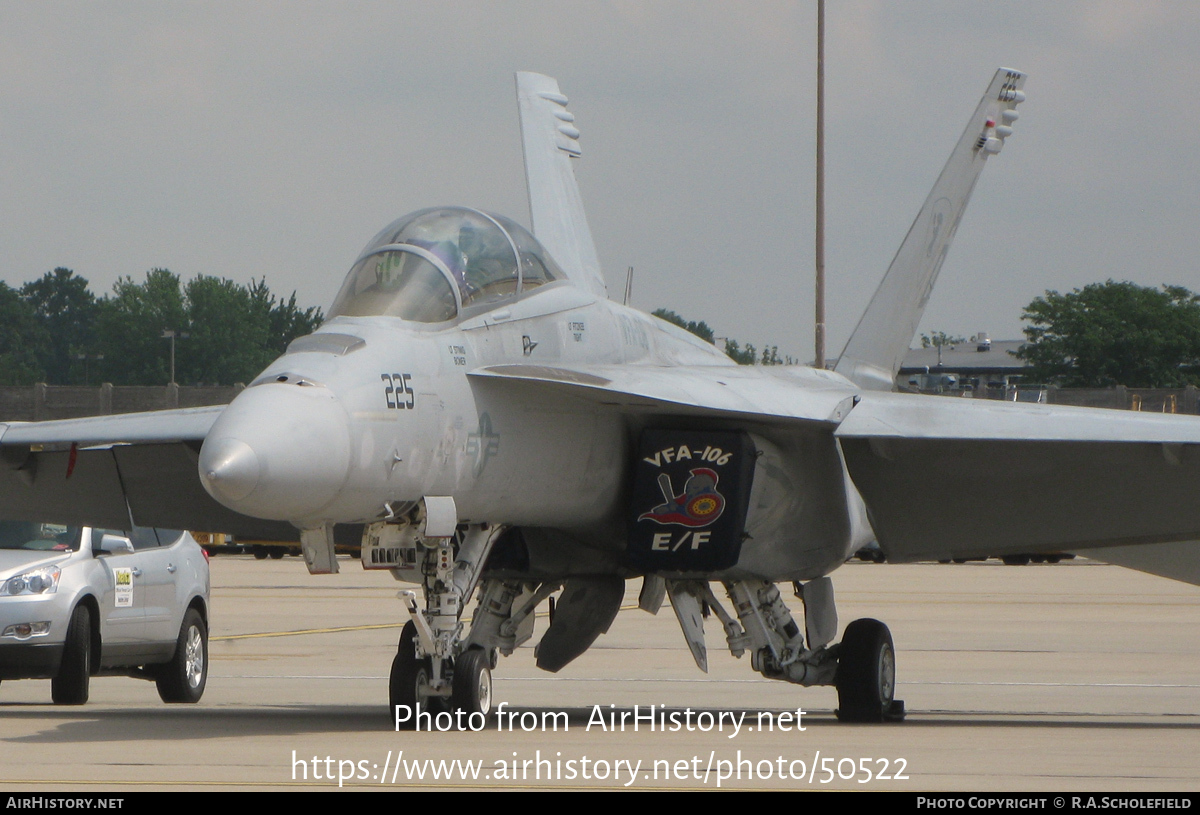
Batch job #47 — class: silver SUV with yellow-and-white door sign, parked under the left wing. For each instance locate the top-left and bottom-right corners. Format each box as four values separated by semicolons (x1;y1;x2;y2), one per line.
0;521;209;705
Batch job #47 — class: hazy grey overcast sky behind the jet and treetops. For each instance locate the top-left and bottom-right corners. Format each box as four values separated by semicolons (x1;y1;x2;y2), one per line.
0;0;1200;359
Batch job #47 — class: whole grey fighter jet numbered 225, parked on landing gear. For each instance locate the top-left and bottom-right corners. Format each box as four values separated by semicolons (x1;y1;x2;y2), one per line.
7;68;1200;721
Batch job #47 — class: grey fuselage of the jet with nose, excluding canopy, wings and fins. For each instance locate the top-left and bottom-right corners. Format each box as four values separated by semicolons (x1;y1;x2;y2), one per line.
199;207;870;577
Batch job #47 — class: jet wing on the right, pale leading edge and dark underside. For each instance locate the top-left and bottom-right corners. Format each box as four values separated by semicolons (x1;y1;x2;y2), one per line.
835;394;1200;562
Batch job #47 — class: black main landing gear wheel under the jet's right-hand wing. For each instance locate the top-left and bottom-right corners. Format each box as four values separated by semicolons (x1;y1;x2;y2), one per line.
834;619;896;721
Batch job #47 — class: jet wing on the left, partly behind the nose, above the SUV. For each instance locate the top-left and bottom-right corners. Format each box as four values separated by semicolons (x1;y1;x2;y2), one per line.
0;406;296;540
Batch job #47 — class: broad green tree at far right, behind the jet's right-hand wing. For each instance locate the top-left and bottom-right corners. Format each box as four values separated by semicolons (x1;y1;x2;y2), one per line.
1016;280;1200;388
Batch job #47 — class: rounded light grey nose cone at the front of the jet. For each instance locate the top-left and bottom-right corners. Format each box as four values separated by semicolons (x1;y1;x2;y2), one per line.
199;383;349;521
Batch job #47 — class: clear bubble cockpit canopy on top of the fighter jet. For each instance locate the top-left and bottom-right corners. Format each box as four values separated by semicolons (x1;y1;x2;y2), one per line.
329;206;565;323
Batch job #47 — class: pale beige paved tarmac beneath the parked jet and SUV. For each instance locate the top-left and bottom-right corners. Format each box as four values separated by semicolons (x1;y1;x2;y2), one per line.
0;556;1200;795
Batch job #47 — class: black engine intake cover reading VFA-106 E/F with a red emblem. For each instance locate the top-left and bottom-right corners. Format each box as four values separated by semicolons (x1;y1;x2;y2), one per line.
626;430;756;573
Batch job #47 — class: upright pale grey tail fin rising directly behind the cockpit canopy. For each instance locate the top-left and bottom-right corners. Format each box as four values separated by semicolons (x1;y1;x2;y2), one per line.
517;72;607;296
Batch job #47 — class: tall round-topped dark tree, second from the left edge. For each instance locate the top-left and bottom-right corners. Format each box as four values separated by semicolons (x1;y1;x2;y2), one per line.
20;266;100;385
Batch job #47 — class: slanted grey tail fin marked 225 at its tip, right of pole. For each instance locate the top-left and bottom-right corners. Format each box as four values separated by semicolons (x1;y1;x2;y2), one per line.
835;68;1025;390
